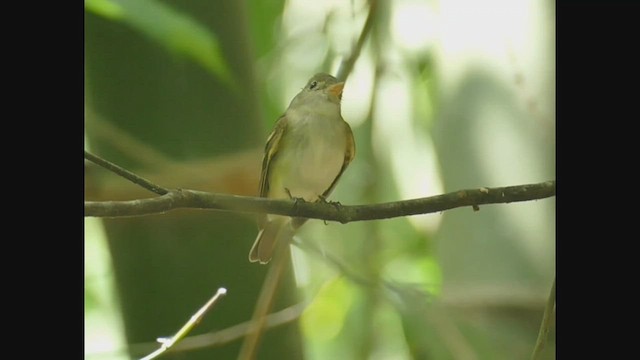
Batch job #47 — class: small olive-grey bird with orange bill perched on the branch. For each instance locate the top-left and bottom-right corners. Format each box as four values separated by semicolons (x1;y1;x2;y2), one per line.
249;73;356;264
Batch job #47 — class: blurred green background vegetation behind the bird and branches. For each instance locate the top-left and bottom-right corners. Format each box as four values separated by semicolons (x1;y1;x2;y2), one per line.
85;0;555;359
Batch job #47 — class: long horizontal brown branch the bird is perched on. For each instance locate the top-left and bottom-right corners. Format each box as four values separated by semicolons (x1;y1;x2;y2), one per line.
84;181;556;224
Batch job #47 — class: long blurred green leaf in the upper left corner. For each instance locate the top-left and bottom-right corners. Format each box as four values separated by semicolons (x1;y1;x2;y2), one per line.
85;0;235;87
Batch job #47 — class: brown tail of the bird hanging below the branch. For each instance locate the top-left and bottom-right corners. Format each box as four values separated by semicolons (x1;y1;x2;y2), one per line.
249;216;294;264
